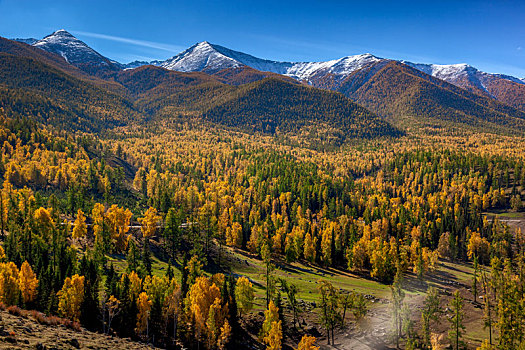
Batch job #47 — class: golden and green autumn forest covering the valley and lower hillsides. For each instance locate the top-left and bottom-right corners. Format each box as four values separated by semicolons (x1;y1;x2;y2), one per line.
0;18;525;350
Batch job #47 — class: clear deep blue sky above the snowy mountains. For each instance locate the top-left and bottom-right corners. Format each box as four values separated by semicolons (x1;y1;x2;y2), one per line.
0;0;525;77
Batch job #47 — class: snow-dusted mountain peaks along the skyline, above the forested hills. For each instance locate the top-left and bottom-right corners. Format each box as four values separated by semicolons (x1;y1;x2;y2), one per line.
14;29;525;93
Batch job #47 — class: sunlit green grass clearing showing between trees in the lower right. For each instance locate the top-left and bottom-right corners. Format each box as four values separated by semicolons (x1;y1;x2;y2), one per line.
77;241;488;349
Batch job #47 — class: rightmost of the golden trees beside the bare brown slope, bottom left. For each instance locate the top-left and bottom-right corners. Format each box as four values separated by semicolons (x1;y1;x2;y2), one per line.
57;275;84;321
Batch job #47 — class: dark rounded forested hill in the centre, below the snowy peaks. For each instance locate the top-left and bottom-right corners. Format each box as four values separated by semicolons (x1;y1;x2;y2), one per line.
204;79;401;143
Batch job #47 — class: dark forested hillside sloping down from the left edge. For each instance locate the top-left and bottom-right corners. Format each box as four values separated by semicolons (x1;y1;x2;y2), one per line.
0;53;143;131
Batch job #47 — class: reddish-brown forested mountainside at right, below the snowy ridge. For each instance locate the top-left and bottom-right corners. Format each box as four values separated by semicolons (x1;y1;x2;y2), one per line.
336;61;525;134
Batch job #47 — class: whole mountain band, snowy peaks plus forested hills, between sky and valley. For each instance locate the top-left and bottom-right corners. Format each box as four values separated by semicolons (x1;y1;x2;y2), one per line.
0;30;525;137
